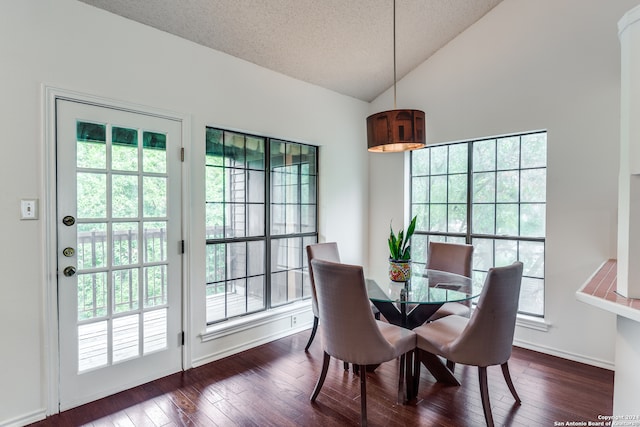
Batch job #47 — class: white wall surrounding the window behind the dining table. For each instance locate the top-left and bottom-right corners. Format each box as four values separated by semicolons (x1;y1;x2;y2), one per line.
369;0;638;368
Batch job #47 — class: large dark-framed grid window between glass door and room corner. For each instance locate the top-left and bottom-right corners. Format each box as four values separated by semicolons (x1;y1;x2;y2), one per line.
206;128;317;324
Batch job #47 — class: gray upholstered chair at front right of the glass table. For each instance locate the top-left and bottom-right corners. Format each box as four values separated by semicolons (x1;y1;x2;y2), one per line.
414;261;522;426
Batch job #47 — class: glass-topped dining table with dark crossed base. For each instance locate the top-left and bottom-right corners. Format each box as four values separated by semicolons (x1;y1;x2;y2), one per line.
366;269;482;394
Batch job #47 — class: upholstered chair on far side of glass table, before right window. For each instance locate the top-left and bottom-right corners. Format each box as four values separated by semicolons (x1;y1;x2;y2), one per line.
427;242;473;320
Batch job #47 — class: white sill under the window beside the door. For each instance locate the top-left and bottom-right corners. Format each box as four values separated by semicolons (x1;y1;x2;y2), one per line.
200;300;311;342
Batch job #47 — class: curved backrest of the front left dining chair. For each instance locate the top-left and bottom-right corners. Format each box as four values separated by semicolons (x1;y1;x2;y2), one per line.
311;259;398;365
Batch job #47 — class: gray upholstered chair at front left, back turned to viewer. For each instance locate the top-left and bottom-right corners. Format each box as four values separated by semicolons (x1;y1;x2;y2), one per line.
311;259;416;425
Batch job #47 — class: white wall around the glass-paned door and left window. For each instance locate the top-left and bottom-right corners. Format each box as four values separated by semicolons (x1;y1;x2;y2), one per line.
0;0;368;425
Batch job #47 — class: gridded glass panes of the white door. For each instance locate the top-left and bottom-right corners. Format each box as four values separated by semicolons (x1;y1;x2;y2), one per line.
76;120;168;373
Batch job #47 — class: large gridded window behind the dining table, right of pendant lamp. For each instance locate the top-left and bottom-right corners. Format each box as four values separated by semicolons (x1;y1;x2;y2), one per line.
411;132;547;316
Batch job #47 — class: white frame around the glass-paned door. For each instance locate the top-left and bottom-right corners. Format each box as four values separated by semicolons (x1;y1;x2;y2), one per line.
41;84;192;416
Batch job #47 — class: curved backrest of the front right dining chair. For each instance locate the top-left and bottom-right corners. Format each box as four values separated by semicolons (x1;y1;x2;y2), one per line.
449;261;523;366
